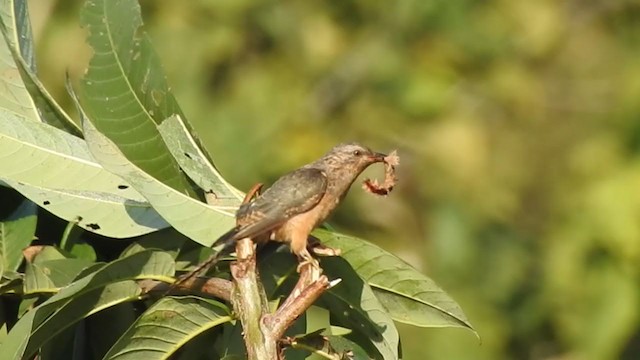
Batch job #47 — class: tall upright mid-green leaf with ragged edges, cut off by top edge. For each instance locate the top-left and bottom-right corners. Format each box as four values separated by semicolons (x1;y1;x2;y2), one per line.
80;0;191;194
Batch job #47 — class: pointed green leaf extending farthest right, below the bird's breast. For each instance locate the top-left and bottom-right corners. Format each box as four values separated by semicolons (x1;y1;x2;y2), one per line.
315;230;475;333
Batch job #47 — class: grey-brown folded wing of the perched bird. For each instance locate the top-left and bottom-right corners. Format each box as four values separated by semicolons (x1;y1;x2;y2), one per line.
234;168;327;239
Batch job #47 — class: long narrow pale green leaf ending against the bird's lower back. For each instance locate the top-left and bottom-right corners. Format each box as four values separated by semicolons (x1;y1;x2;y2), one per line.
82;118;235;246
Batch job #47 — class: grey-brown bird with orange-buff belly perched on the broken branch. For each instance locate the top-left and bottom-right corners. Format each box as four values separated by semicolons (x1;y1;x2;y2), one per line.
174;143;387;286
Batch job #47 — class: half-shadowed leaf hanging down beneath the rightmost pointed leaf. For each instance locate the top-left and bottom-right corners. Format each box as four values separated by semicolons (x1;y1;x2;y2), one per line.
320;257;400;360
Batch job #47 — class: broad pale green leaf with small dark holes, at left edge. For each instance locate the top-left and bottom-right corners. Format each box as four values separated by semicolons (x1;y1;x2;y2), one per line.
0;109;168;237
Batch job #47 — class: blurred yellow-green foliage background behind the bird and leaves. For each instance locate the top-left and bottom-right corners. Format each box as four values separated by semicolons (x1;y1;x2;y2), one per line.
29;0;640;360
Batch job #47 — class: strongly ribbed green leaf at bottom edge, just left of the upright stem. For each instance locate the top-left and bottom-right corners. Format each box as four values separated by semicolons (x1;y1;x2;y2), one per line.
104;297;232;360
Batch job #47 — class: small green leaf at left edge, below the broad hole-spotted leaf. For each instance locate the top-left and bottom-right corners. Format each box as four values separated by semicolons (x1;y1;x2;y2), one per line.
0;200;38;275
